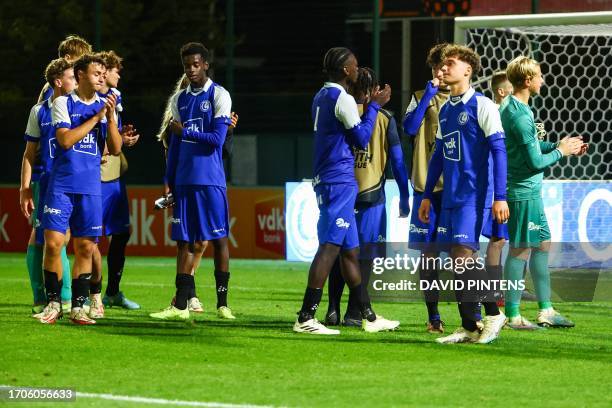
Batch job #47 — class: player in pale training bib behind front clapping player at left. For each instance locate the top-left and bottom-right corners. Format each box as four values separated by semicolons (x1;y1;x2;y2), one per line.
89;51;140;319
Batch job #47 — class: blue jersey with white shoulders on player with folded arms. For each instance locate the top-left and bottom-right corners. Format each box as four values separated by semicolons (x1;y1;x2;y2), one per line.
166;79;232;187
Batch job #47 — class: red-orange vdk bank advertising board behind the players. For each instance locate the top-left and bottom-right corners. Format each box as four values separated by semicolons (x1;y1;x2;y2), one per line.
0;186;285;259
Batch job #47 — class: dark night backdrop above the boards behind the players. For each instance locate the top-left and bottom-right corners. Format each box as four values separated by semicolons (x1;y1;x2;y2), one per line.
0;0;460;185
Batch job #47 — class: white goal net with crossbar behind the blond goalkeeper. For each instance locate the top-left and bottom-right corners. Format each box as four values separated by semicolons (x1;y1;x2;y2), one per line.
455;12;612;180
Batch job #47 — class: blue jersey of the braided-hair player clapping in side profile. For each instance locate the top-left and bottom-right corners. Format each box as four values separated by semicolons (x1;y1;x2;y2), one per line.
311;82;380;185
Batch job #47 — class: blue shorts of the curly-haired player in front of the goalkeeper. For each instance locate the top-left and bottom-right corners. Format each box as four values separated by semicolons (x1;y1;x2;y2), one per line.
437;205;491;251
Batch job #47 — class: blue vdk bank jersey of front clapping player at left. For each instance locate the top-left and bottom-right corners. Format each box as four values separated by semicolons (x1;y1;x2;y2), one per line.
49;92;106;195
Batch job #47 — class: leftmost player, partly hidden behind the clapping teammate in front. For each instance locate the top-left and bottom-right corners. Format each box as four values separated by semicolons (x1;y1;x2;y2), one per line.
19;58;76;314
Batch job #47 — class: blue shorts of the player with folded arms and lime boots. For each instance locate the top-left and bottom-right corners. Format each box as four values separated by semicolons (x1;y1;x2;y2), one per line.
171;185;229;242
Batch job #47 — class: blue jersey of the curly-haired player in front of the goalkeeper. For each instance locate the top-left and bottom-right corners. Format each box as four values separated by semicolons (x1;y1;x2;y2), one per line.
436;88;505;208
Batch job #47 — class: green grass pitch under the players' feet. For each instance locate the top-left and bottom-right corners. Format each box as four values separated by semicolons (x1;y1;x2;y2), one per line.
0;254;612;407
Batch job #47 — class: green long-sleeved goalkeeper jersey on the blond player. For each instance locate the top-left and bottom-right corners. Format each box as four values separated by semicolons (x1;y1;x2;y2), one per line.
500;95;563;201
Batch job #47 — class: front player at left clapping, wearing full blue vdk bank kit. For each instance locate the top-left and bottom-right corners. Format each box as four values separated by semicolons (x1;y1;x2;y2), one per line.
40;54;121;325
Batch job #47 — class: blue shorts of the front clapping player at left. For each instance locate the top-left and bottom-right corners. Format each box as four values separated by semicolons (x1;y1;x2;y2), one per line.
42;190;102;238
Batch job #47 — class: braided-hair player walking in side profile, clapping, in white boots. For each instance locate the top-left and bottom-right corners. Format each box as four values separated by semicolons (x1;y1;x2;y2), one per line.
293;47;397;335
